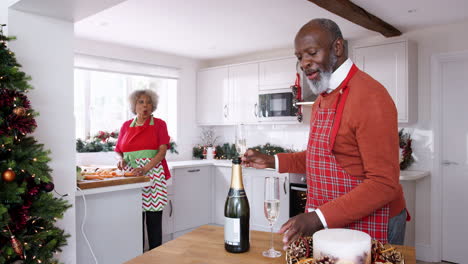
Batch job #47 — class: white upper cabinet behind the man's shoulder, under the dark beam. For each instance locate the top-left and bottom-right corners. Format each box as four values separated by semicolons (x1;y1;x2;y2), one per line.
353;40;418;123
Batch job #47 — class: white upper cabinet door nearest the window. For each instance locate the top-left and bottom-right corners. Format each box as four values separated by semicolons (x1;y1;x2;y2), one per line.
197;67;230;125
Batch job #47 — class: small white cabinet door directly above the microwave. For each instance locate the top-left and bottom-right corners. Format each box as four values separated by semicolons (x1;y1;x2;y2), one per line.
259;57;297;91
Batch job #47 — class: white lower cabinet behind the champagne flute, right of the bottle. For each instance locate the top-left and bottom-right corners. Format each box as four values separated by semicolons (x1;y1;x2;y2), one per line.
246;169;289;232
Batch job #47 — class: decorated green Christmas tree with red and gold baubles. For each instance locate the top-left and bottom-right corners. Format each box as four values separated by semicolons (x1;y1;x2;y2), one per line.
0;25;70;264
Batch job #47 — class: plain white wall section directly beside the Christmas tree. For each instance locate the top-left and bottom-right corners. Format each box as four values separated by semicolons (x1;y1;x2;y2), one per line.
8;10;76;264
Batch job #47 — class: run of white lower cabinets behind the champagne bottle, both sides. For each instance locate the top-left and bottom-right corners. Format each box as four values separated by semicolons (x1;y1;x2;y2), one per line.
163;165;289;243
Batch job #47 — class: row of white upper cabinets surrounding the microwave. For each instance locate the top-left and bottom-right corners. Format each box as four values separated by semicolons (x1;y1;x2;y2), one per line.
197;57;299;125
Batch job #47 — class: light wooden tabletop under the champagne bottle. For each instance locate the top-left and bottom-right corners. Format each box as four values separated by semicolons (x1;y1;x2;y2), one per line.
125;225;416;264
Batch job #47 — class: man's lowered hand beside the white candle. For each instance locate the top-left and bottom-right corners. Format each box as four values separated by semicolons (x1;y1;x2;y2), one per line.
279;212;323;250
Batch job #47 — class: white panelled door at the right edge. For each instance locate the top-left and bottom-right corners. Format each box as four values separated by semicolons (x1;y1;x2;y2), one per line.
441;58;468;263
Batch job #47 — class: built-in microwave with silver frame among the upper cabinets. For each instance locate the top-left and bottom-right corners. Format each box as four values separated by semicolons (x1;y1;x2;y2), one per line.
258;89;298;122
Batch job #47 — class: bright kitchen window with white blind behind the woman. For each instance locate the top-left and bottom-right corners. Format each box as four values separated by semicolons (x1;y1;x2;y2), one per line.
74;55;178;141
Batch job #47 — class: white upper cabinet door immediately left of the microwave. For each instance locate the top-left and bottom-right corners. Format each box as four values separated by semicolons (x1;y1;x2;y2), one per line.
229;63;258;124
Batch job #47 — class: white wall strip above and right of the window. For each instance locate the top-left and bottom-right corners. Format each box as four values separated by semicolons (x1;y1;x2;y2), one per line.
75;39;200;161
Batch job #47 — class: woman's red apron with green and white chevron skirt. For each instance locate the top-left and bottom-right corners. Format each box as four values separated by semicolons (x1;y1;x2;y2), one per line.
122;116;167;211
